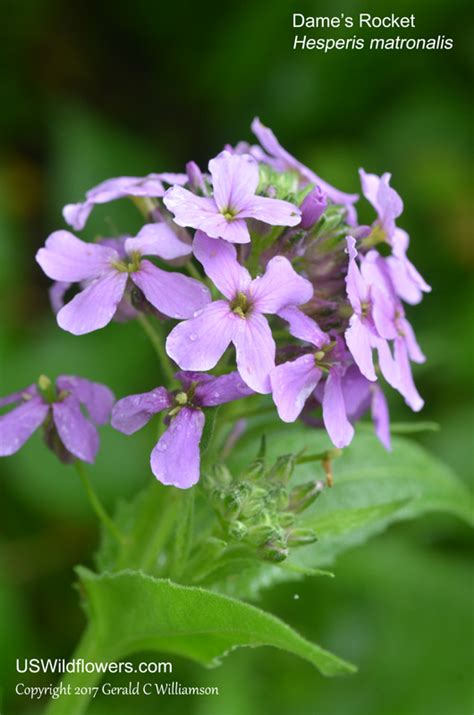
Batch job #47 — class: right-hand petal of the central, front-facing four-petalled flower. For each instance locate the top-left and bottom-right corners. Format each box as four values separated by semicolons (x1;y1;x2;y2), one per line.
249;256;313;313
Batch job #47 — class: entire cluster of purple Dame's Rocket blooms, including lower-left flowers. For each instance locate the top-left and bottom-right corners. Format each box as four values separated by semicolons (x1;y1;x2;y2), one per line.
0;119;430;488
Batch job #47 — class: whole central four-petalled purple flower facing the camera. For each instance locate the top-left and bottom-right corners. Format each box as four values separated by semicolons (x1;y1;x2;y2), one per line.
166;231;313;393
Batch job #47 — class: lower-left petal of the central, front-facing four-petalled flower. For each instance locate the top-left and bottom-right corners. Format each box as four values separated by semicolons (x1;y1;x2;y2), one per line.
166;300;236;370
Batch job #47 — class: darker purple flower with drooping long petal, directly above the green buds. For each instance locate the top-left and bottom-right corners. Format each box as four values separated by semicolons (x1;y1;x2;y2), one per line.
112;372;252;489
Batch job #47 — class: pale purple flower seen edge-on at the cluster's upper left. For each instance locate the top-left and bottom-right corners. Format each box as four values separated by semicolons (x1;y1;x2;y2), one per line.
63;173;188;231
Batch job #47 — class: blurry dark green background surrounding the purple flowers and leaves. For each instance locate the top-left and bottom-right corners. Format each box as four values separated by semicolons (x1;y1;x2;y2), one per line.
0;0;474;715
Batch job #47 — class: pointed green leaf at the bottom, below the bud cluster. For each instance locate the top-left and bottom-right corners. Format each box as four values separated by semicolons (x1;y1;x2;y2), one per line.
78;567;355;676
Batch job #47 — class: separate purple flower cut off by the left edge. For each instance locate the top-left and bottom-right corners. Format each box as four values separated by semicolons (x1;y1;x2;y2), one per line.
0;375;115;463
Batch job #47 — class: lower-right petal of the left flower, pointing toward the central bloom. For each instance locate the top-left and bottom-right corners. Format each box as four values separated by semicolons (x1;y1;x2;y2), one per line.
131;260;211;318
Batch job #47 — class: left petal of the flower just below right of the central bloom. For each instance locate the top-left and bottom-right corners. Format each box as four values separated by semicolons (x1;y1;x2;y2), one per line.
270;355;323;422
